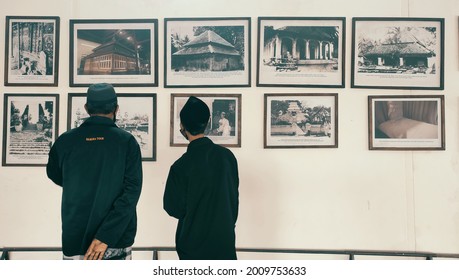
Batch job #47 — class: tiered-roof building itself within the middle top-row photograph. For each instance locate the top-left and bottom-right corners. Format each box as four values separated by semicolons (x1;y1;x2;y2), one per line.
172;30;244;71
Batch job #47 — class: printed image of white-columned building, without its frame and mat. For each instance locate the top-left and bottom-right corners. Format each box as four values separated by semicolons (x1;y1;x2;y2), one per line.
262;26;340;72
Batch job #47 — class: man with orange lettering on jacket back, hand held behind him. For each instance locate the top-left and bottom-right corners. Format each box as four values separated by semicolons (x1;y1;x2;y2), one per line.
46;84;142;260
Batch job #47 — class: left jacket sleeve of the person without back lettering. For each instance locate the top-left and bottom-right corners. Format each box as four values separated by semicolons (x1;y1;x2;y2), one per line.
163;166;186;219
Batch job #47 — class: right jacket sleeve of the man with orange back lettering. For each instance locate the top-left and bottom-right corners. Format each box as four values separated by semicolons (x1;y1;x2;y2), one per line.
95;137;142;248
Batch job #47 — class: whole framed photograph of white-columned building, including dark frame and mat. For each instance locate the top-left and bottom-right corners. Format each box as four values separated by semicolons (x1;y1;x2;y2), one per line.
257;17;346;88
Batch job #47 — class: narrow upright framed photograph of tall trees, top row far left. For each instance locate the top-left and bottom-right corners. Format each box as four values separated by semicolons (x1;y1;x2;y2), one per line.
5;16;60;86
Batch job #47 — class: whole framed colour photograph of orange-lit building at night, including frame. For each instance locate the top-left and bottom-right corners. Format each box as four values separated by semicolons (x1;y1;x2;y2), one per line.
70;19;158;87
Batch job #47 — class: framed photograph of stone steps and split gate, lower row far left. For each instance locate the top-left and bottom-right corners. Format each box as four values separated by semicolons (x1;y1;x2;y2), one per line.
2;93;59;166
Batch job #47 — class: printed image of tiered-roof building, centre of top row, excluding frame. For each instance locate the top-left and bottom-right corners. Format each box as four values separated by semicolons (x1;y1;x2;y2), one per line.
171;26;244;72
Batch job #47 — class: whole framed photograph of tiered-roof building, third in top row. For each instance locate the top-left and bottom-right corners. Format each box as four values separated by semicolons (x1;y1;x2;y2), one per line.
164;18;251;87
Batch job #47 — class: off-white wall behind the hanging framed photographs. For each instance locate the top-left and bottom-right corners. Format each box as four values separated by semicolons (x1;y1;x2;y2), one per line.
0;0;459;258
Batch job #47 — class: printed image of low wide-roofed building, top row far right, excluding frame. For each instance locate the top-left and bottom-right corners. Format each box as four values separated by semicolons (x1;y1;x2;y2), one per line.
358;27;436;74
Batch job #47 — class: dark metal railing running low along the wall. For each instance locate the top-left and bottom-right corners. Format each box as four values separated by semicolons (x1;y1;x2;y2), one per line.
0;247;459;260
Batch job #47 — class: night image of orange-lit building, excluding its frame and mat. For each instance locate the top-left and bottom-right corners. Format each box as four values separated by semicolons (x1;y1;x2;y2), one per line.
77;29;151;75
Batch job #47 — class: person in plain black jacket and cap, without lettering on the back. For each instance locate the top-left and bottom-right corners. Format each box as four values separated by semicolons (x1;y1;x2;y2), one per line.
163;96;239;260
